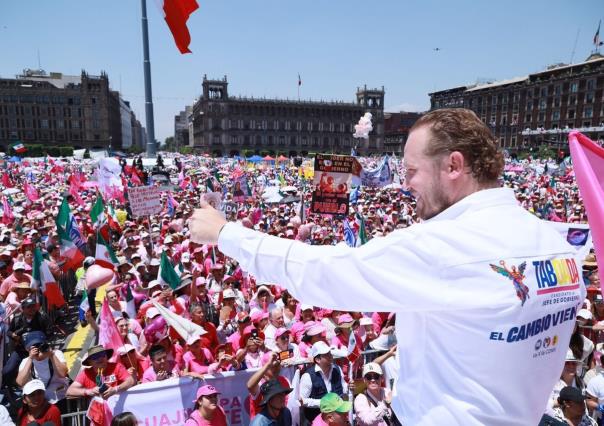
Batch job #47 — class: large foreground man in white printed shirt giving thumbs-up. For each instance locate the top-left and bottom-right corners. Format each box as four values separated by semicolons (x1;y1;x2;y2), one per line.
190;108;585;426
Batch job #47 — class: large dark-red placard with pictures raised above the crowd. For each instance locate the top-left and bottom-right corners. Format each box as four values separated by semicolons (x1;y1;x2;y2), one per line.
310;154;362;215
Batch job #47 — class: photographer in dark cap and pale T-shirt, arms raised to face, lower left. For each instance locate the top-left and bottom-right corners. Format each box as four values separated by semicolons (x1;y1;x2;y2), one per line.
17;331;69;412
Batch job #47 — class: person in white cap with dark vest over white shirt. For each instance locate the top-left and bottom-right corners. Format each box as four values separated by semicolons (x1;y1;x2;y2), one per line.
300;341;348;424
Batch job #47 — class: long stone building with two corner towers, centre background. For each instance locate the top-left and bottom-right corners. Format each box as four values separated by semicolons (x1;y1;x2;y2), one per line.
191;76;385;156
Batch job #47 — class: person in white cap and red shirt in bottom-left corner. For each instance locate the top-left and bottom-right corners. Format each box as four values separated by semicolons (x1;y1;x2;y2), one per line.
17;379;61;426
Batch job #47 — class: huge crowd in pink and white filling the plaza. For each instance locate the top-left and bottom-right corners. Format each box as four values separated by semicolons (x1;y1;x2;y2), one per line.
0;141;604;426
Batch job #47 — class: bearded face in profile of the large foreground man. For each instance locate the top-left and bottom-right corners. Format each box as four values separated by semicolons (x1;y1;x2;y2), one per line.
404;126;453;220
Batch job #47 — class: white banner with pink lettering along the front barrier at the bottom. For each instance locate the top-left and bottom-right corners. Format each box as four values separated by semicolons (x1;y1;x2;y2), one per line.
107;367;297;426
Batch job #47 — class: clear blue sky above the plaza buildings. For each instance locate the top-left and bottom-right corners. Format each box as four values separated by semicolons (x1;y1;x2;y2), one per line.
0;0;604;141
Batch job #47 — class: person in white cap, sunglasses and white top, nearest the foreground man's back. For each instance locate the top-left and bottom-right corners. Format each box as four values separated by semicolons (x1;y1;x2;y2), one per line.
354;362;400;426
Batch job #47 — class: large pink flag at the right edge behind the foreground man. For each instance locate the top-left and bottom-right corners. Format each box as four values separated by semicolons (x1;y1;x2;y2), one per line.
568;132;604;294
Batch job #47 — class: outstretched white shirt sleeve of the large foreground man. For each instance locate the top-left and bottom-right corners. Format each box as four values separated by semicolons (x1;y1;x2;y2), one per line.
218;222;446;312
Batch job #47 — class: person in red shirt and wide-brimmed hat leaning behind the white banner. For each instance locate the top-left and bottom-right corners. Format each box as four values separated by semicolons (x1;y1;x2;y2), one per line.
67;345;135;399
